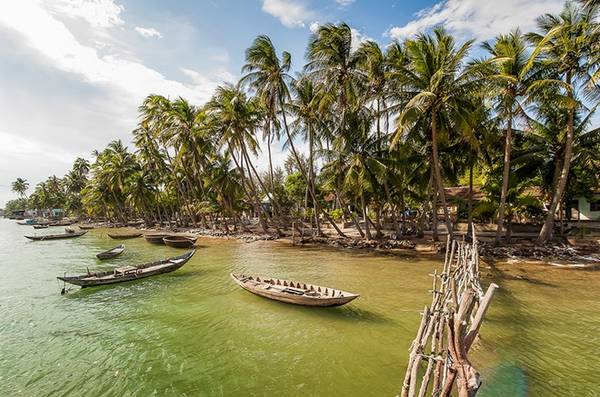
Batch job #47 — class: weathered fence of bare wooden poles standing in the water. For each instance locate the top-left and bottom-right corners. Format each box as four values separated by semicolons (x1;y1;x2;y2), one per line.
400;227;498;397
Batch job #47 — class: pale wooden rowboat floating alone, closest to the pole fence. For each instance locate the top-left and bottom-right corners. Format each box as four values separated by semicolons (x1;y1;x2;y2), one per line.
231;273;360;306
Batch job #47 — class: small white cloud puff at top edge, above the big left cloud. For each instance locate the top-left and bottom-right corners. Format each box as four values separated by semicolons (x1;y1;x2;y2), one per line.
45;0;124;28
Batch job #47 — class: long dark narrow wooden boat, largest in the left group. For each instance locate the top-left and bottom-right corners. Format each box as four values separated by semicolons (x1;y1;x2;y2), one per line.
57;250;196;288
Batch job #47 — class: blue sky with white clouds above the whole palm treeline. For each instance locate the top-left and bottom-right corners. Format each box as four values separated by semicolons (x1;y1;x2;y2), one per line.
0;0;562;205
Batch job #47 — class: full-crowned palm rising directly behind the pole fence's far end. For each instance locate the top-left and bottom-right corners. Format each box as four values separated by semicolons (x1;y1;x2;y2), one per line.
394;28;480;240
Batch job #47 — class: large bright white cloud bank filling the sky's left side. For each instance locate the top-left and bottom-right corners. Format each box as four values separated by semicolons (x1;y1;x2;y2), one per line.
0;0;233;204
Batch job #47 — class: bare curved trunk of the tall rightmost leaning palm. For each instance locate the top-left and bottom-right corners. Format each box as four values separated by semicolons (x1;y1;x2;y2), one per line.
537;72;575;244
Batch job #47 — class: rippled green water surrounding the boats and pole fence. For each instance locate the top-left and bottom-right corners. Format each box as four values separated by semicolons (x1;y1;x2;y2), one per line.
0;220;600;397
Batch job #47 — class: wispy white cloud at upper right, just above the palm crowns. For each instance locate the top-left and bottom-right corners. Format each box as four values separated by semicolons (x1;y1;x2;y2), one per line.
387;0;563;40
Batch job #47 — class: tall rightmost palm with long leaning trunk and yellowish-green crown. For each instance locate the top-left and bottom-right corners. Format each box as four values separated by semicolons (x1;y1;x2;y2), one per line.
527;2;599;243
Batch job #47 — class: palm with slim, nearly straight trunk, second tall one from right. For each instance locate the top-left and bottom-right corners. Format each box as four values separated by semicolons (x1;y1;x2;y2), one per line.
482;30;536;244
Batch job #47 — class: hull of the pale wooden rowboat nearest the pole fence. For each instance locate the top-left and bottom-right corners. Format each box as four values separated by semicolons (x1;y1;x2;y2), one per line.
231;273;360;307
